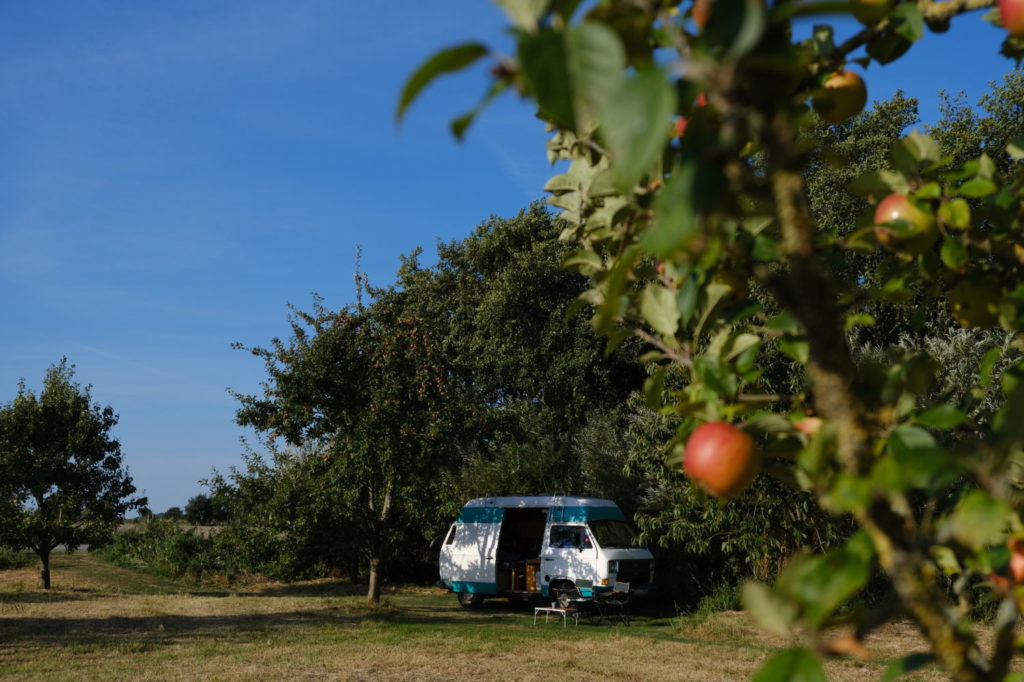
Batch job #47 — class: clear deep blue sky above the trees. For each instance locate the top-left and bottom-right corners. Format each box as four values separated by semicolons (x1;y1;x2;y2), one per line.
0;0;1013;511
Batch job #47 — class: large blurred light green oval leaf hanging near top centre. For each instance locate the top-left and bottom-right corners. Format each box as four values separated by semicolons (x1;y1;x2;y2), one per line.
599;68;676;188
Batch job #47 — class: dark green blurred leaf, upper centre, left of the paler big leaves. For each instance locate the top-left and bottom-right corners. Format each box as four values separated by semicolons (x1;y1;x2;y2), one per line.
518;29;575;130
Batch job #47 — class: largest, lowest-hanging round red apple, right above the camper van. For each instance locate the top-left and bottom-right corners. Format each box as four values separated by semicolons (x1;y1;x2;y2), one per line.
683;422;761;499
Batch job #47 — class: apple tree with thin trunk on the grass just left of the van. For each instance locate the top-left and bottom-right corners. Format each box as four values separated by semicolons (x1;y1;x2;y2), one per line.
234;289;474;603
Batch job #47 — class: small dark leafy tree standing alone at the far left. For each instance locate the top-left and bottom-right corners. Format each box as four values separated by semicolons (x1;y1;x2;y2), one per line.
0;359;146;590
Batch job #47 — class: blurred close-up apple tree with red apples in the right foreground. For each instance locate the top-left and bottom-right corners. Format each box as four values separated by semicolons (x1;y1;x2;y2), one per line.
397;0;1024;680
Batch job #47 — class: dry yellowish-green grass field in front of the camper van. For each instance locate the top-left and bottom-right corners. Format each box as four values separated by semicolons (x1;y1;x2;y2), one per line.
0;553;944;682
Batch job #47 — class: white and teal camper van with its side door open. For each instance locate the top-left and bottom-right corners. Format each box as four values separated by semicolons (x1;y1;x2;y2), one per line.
439;497;654;608
